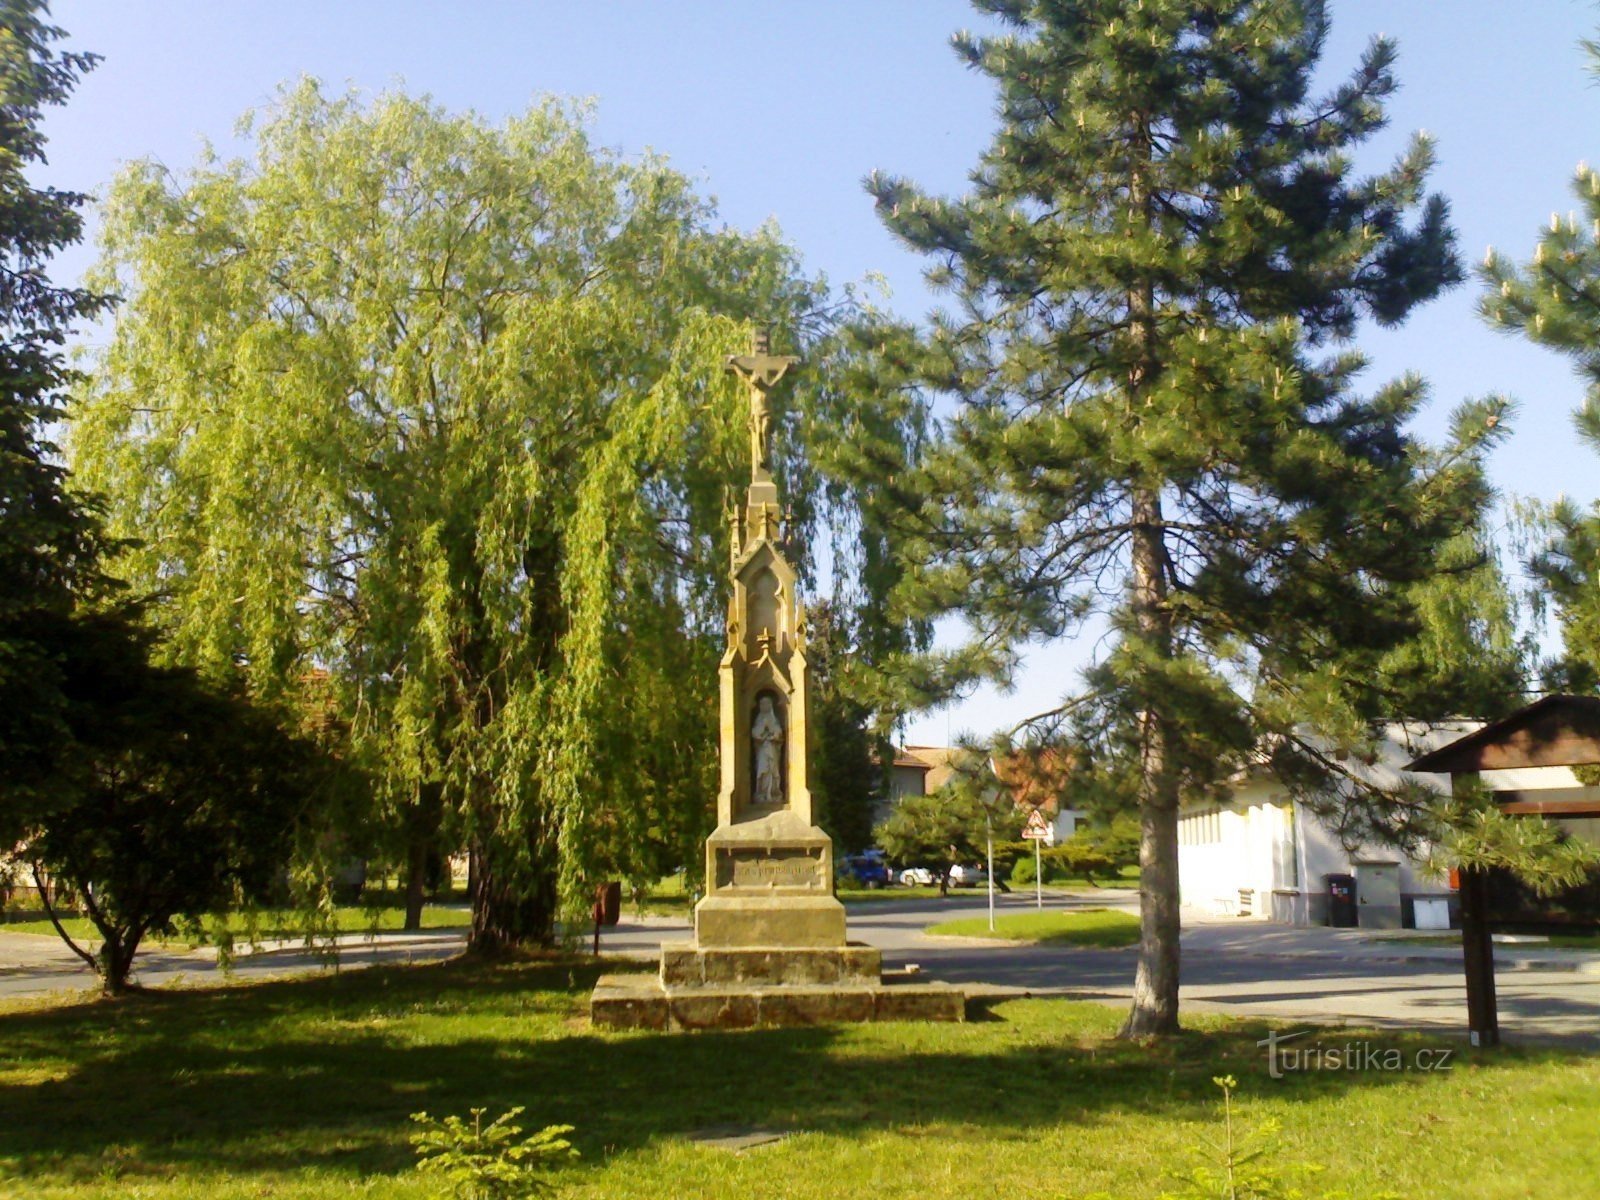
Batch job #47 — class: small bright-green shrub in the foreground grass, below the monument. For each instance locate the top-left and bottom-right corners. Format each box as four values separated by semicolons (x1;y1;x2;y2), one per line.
411;1107;578;1200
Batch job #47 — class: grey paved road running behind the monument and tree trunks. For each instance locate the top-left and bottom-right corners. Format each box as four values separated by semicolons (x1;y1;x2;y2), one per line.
0;890;1600;1046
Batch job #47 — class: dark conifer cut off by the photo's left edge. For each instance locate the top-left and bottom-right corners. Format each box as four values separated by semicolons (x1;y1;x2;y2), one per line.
0;0;110;846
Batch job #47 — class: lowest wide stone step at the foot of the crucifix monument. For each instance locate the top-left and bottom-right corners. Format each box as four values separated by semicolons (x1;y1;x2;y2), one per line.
589;974;966;1029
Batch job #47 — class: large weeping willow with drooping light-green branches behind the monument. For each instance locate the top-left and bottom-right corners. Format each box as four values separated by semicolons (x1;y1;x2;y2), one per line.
74;82;909;950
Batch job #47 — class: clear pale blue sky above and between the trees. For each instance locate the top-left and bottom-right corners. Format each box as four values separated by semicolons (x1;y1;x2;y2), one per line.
40;0;1600;742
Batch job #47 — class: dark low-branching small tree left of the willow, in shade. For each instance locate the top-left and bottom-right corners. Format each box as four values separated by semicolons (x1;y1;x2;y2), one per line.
16;621;325;994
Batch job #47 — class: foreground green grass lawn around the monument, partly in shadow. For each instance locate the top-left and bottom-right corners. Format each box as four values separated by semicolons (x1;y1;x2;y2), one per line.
0;962;1600;1200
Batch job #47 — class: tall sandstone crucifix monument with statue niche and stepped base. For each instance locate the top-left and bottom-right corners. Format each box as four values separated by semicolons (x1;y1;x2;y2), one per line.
590;336;965;1029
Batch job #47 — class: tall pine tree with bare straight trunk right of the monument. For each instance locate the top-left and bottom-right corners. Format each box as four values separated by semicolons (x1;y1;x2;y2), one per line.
867;0;1502;1037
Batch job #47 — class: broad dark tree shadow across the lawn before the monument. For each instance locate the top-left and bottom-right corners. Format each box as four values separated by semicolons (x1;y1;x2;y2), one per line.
0;962;1587;1176
